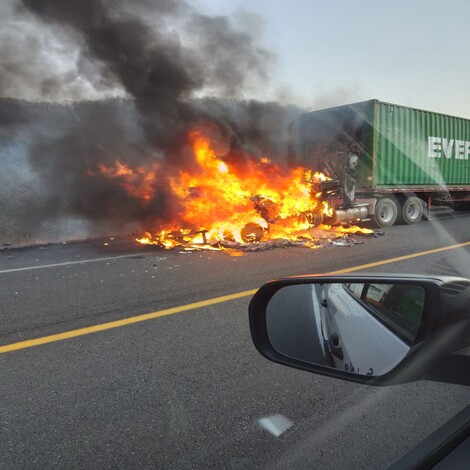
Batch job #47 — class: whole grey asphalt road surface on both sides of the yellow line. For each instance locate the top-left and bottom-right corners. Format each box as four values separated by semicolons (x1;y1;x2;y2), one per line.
0;212;470;469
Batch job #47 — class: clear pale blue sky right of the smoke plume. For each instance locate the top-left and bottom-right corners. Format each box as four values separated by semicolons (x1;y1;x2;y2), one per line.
193;0;470;118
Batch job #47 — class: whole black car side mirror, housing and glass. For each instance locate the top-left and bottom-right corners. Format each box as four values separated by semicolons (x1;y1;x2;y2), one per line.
249;275;470;385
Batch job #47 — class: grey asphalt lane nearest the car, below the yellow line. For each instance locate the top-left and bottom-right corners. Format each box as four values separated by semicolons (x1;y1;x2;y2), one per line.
0;288;468;469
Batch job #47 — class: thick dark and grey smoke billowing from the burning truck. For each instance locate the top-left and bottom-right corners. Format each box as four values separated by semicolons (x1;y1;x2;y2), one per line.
0;0;298;241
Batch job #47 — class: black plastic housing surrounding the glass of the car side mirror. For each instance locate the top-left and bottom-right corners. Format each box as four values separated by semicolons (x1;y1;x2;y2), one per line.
249;274;470;385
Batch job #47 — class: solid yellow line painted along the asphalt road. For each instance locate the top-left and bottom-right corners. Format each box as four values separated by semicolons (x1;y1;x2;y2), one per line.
0;241;470;354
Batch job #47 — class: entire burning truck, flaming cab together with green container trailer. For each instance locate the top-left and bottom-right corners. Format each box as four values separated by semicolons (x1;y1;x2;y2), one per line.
89;100;470;249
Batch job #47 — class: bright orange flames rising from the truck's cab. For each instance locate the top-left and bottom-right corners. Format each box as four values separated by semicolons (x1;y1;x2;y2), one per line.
89;125;372;248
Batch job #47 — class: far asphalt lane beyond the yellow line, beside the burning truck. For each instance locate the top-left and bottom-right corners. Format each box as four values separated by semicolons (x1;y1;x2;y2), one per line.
0;210;470;344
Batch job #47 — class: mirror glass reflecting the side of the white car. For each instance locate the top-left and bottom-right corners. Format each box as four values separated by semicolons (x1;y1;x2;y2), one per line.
266;282;425;376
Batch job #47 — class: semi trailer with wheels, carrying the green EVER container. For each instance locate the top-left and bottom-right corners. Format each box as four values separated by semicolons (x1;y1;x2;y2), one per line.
288;100;470;227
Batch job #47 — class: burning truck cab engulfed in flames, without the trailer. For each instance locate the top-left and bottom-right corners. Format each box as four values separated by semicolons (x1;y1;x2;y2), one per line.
88;123;371;249
